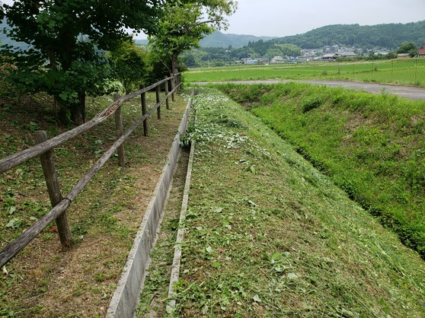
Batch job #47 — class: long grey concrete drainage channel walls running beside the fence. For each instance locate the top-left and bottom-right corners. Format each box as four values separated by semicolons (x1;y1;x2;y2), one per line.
106;93;193;318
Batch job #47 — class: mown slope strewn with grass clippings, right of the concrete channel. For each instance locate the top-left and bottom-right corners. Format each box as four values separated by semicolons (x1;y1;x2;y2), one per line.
171;89;425;317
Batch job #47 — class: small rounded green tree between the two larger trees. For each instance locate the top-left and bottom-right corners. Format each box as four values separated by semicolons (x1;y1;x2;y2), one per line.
107;41;149;94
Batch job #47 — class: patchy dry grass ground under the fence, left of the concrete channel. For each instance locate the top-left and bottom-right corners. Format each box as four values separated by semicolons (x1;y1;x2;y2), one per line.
0;85;187;317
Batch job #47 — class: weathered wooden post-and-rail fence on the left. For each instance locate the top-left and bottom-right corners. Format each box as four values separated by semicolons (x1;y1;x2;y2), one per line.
0;73;181;268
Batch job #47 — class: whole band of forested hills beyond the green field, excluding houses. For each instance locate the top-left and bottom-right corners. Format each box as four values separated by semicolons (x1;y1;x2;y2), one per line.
184;21;425;67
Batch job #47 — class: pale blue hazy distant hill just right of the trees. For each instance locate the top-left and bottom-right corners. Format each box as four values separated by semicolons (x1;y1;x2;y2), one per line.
199;31;276;48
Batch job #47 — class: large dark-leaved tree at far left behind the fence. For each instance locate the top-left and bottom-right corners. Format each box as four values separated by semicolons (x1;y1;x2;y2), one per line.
1;0;162;124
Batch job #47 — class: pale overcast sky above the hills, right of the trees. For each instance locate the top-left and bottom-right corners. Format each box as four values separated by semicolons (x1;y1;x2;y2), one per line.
223;0;425;37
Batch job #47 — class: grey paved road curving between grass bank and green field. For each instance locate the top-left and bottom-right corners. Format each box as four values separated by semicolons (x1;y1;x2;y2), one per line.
193;80;425;100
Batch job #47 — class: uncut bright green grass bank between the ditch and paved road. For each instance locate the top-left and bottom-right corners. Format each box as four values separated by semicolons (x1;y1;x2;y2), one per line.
214;83;425;257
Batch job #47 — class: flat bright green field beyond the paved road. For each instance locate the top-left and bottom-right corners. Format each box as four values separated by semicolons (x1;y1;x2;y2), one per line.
184;59;425;86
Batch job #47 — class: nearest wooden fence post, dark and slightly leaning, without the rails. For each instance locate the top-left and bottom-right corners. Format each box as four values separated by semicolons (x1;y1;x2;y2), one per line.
34;130;72;247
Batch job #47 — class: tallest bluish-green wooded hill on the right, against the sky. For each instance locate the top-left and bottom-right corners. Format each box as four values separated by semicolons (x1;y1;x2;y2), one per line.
271;21;425;49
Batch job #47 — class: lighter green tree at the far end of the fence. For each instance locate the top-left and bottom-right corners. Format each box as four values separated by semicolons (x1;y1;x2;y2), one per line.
149;0;237;73
